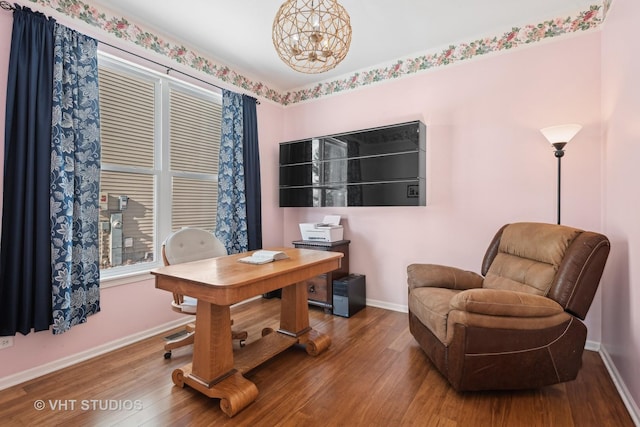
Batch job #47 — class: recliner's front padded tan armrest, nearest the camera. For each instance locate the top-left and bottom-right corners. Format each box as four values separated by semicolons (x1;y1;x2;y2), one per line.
449;289;564;317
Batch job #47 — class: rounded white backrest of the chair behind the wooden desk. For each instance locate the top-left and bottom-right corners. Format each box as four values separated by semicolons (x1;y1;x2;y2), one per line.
162;227;227;265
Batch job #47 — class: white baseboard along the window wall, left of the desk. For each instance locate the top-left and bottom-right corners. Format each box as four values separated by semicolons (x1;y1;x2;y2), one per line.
0;316;193;390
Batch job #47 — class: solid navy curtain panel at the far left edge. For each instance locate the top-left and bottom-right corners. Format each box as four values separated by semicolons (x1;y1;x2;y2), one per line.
0;6;55;336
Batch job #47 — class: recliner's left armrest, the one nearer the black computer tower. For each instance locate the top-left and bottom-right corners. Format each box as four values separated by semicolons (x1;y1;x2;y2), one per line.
407;264;484;290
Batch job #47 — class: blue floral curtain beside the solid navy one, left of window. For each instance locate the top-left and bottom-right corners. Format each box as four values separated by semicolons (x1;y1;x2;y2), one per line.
50;24;100;334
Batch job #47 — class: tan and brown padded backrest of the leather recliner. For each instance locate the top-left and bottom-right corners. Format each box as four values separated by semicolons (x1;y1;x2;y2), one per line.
482;222;610;319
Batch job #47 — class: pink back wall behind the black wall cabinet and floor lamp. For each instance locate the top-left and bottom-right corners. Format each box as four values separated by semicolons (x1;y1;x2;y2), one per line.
284;32;602;332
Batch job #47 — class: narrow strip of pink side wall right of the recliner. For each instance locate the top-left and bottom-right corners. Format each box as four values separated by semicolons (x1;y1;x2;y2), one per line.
602;0;640;414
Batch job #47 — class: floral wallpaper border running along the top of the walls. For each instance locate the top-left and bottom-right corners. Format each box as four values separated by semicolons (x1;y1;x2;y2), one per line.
28;0;612;106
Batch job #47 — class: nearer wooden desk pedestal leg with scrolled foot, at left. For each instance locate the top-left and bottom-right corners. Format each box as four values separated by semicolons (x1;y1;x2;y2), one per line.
172;300;258;417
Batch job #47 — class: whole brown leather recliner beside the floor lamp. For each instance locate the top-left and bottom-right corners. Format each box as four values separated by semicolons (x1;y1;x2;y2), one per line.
407;223;610;391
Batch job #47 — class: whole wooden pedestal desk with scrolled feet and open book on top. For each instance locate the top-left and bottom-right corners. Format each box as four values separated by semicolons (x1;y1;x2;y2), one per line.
151;248;343;417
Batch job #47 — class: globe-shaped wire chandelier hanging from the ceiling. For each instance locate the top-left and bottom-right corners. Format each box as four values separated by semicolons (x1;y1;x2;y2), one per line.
272;0;351;74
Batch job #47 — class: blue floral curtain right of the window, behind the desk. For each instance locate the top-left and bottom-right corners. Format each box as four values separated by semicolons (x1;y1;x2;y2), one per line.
216;90;248;254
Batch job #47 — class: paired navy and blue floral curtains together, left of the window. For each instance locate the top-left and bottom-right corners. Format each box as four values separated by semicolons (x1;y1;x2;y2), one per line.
0;5;100;336
